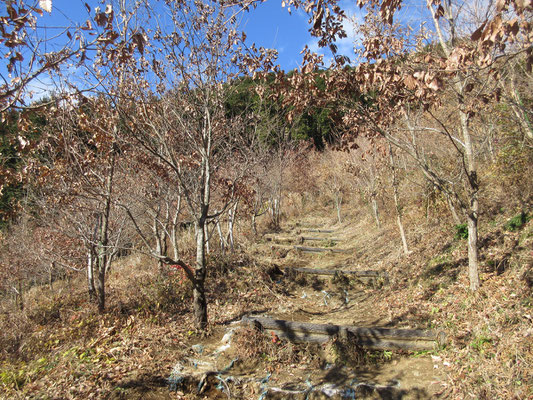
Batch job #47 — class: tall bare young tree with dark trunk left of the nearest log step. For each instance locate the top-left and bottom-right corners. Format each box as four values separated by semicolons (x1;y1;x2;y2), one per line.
99;1;273;329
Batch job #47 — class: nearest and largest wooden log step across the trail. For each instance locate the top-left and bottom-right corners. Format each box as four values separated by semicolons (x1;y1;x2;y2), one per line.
241;316;446;351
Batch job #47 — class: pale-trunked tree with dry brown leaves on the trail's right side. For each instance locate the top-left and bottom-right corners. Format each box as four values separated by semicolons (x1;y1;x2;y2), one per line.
276;0;533;290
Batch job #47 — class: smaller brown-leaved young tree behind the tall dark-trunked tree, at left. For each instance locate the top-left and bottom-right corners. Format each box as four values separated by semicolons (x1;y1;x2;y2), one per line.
28;98;124;312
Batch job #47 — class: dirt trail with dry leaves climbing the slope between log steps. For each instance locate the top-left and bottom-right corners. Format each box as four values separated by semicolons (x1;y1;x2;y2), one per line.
169;217;445;400
